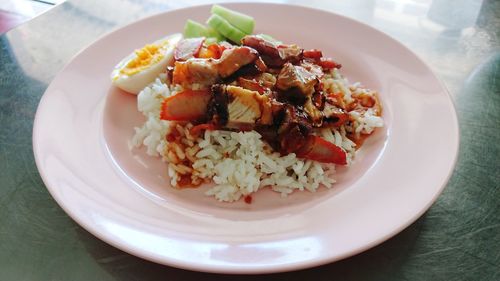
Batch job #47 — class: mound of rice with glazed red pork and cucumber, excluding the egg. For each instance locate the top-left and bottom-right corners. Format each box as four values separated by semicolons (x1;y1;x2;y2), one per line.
114;6;383;202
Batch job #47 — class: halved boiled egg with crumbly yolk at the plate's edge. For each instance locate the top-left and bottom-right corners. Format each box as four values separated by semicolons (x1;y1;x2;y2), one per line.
111;33;182;95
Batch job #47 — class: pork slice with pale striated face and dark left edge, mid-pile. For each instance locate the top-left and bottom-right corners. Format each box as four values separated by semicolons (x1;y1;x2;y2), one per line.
212;85;273;130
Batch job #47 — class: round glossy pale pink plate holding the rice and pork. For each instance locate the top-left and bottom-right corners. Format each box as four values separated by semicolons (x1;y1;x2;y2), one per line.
33;4;458;273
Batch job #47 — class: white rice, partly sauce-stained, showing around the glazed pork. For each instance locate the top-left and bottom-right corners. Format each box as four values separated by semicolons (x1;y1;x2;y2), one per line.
131;71;383;202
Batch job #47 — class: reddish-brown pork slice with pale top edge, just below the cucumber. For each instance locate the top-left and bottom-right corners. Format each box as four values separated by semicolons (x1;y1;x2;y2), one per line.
216;47;259;78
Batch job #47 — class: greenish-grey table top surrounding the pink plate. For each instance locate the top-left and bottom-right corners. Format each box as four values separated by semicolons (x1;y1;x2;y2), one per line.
0;0;500;281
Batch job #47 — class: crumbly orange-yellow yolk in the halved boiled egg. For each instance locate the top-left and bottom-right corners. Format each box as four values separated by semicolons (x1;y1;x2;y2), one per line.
120;44;163;76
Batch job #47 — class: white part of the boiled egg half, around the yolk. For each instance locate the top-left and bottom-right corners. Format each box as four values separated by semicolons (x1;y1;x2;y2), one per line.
111;33;182;95
